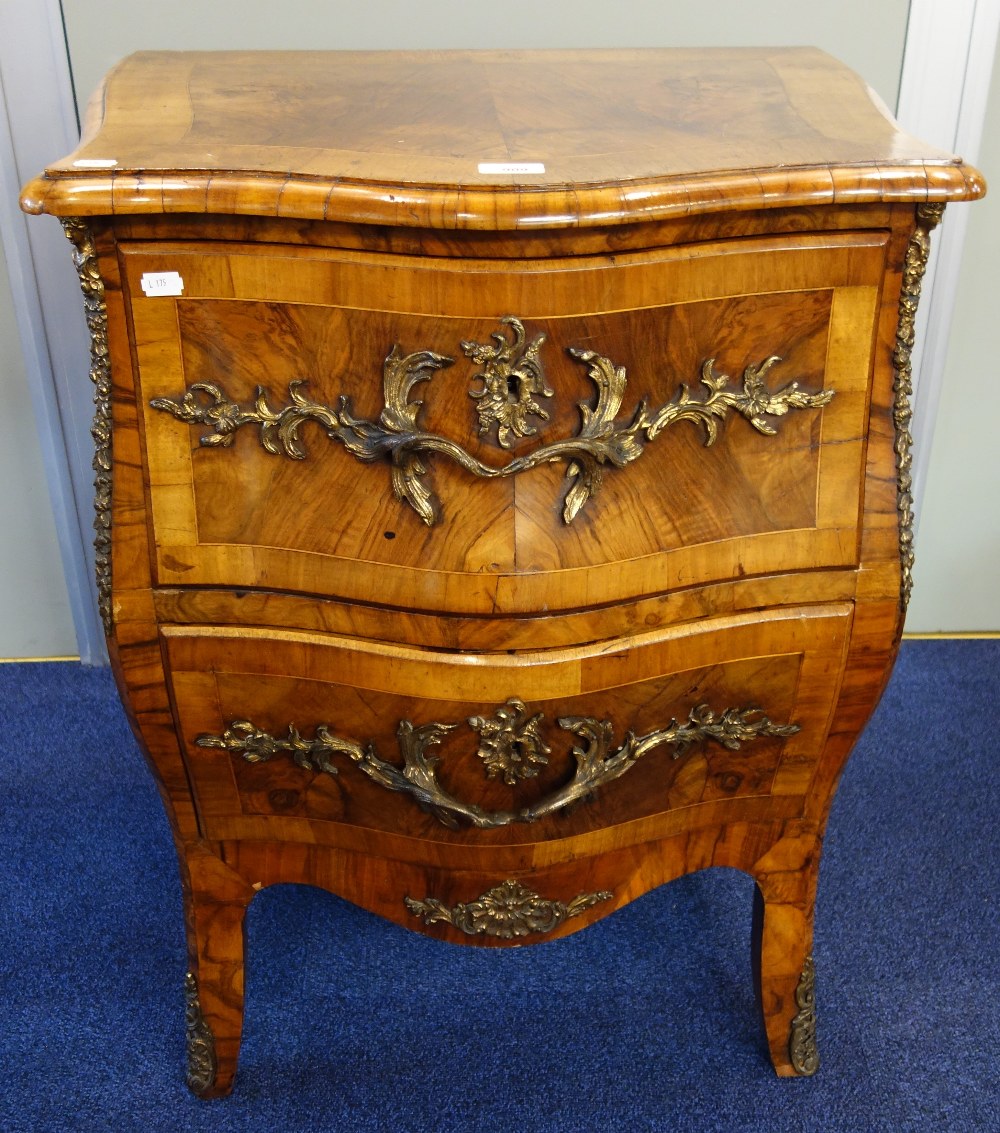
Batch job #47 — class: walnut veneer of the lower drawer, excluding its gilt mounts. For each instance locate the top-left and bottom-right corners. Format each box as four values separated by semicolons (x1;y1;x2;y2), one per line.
163;603;852;847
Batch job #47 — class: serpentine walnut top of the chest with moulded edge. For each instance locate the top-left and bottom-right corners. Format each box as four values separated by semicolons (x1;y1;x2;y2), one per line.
22;48;985;229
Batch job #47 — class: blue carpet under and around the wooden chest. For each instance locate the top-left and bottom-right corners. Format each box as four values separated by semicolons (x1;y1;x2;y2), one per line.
0;641;1000;1133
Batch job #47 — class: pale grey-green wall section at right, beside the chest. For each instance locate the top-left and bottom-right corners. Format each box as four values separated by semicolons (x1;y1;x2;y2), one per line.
906;33;1000;633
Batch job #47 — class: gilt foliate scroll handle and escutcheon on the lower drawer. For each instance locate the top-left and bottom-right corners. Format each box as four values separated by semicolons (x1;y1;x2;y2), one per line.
195;698;800;829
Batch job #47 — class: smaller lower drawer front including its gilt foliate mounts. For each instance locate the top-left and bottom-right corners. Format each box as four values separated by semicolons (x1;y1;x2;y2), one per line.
161;604;852;847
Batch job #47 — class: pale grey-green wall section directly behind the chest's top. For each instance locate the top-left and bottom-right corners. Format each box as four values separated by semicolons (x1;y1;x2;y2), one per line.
62;0;909;107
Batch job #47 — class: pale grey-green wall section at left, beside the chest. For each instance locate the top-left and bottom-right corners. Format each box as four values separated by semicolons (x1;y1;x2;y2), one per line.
0;246;75;658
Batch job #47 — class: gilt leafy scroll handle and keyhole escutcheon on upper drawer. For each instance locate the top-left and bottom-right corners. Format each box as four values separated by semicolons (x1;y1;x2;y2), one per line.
149;316;835;527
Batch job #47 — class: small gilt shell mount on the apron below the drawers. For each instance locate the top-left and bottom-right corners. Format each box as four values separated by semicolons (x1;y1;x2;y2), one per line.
403;880;614;940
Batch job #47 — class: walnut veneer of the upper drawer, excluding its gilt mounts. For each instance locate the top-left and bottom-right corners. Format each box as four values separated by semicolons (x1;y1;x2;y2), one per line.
120;232;888;613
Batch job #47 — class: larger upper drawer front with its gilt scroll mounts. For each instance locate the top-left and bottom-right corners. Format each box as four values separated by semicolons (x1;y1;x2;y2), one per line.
121;232;887;613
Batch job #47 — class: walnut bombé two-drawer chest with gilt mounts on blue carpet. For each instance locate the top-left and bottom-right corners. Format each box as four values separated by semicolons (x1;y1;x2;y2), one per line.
23;49;983;1096
